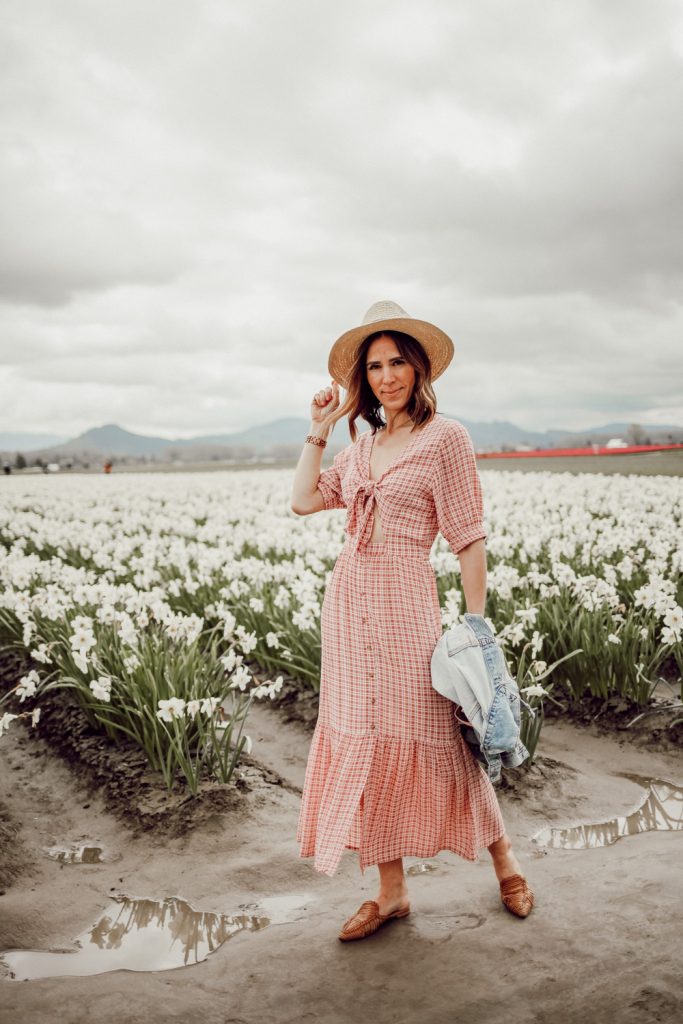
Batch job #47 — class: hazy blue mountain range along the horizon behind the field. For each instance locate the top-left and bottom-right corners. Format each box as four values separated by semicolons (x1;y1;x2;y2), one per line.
0;414;683;462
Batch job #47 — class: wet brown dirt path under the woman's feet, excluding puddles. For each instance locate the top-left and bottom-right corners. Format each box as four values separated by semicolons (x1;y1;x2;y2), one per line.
0;706;683;1024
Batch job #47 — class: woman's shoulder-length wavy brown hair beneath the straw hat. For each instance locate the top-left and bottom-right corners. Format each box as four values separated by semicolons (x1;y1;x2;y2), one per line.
326;331;436;441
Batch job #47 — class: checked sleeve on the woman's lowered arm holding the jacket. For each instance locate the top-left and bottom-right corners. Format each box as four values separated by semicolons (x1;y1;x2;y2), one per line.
432;420;486;554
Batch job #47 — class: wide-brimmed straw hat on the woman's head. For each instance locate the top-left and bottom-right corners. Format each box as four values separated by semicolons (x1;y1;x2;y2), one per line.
328;299;455;390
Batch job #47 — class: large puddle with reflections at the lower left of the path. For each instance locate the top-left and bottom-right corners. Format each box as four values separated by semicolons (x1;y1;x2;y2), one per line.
0;896;270;981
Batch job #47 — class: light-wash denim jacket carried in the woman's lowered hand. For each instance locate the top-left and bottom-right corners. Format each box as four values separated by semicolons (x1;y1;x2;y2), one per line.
431;612;535;782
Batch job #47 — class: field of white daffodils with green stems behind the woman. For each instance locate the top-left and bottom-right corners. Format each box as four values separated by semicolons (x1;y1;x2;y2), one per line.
0;469;683;792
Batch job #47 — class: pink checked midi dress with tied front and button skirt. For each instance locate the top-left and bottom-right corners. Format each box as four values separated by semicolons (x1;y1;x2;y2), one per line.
296;413;505;876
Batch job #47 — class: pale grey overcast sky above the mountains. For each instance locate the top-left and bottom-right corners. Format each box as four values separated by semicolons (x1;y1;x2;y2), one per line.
0;0;683;436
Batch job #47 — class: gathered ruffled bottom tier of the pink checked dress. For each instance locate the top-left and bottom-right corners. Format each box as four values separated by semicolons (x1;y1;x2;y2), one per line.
297;720;505;876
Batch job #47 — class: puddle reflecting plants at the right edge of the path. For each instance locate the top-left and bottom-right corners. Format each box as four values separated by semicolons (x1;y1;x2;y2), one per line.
533;772;683;850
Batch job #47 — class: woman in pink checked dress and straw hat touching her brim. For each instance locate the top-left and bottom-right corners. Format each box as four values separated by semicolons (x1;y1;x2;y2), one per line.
292;302;533;941
